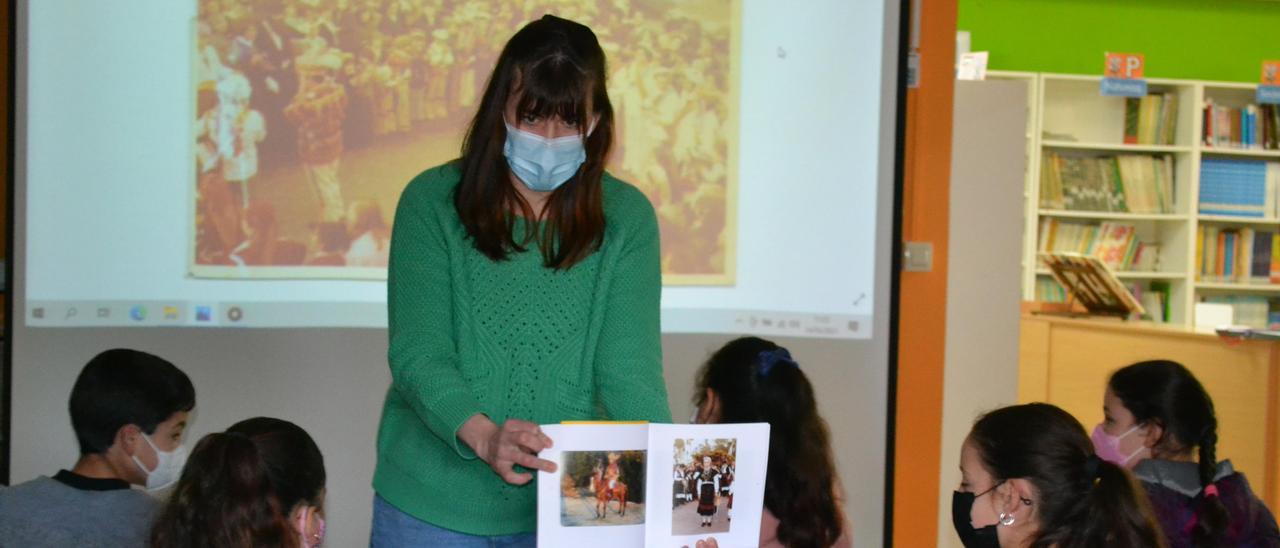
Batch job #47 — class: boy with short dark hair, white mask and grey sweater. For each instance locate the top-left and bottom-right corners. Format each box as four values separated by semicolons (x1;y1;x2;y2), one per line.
0;348;196;547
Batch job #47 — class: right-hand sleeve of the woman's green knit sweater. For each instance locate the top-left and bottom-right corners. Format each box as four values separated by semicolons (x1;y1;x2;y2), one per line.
595;191;671;424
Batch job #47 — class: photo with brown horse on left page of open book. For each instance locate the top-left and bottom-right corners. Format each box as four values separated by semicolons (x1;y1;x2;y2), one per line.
561;451;648;528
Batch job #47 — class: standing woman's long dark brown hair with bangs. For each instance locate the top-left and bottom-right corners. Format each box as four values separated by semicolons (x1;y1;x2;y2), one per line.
453;15;613;269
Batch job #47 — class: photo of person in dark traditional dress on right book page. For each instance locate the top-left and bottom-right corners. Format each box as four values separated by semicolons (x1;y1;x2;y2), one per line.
671;438;737;535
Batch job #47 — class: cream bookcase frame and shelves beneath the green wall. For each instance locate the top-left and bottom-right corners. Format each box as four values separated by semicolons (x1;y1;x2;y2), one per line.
1003;70;1280;326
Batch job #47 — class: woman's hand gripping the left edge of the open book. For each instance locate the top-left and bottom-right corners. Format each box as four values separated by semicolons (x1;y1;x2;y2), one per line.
458;415;556;485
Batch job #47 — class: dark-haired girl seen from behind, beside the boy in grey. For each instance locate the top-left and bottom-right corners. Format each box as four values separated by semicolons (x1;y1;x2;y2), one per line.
151;417;325;548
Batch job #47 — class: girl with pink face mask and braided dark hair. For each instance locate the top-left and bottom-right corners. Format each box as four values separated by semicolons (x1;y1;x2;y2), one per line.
1093;360;1280;548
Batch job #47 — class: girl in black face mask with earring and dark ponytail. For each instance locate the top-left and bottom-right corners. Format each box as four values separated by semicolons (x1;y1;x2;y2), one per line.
951;403;1165;548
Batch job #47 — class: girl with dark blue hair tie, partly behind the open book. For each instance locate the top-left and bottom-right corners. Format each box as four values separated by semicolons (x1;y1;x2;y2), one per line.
694;337;852;548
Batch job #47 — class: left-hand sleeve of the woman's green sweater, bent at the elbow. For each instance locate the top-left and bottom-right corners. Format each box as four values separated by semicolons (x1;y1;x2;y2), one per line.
387;181;481;458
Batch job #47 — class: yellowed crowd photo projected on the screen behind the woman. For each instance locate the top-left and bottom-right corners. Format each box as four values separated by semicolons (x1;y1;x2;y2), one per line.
189;0;740;284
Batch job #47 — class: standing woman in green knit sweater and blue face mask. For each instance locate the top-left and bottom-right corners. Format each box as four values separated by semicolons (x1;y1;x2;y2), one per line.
371;15;671;547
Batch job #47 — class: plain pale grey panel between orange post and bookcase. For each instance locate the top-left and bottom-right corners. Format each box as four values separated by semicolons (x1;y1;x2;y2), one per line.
938;81;1028;548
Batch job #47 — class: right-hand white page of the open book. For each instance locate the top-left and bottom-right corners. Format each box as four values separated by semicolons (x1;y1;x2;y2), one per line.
645;423;769;548
